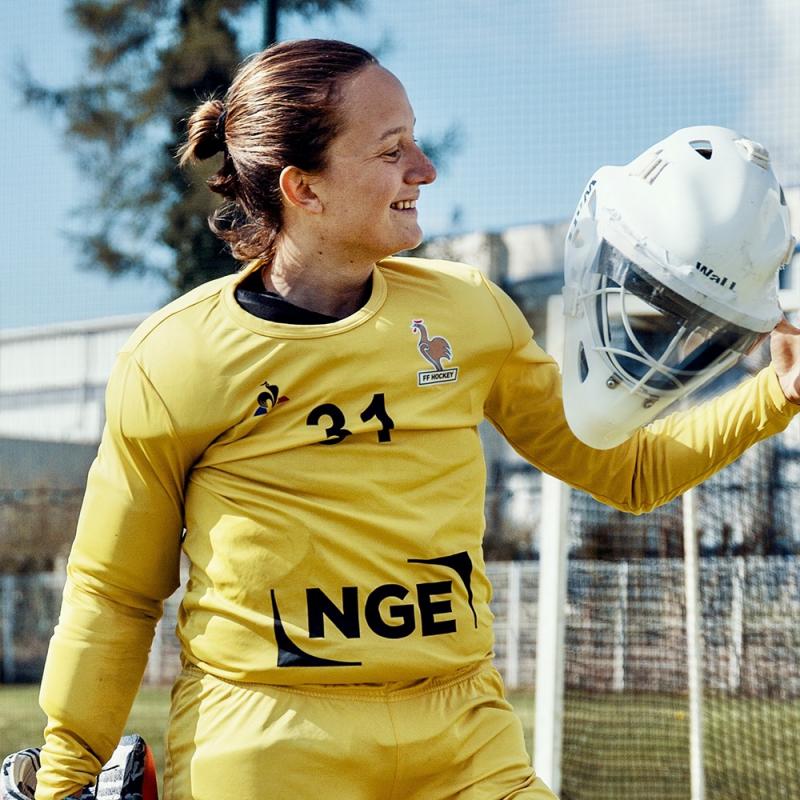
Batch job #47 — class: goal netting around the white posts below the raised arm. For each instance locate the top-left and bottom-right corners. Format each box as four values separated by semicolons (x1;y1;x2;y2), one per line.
561;396;800;800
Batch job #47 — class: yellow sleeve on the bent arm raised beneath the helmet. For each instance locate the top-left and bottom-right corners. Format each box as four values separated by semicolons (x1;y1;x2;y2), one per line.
486;282;800;514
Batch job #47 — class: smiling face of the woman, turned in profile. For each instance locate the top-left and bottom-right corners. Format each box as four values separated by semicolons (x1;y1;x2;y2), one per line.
311;65;436;262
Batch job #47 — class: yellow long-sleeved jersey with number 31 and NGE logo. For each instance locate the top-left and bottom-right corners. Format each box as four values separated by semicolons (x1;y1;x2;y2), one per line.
36;258;800;800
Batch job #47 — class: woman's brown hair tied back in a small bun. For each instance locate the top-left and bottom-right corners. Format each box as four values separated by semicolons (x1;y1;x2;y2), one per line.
178;39;377;260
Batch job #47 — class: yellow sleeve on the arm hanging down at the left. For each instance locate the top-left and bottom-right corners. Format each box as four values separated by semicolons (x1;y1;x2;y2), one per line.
36;354;192;800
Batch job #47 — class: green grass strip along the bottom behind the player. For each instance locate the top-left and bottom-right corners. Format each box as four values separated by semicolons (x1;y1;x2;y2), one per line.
0;685;800;800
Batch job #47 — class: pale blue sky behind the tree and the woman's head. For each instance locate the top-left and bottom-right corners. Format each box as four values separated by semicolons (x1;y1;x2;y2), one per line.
0;0;800;328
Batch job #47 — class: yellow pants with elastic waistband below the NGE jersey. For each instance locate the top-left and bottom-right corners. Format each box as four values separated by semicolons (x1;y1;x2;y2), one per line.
164;664;555;800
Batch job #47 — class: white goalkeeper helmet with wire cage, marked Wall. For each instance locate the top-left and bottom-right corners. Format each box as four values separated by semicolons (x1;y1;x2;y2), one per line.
564;126;794;449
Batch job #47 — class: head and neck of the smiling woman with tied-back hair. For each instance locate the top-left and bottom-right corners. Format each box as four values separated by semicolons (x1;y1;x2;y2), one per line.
181;40;436;318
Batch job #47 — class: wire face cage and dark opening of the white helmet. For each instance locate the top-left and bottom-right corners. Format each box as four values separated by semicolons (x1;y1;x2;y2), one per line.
580;240;766;406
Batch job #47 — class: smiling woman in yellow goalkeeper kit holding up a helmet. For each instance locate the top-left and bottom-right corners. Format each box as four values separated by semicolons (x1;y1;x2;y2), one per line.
36;40;798;800
